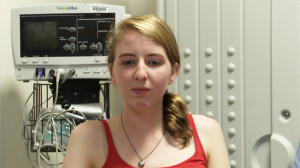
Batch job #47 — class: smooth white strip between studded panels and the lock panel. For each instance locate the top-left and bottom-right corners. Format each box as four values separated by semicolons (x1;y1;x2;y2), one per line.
244;0;272;168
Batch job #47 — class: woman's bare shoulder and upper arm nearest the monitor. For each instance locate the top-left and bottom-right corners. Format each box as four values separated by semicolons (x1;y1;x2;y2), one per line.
63;121;106;168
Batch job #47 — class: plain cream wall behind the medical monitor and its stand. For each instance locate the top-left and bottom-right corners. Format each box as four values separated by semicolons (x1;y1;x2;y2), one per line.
0;0;156;168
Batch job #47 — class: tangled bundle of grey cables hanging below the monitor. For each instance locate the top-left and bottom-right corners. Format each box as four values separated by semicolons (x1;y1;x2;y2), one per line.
22;68;90;168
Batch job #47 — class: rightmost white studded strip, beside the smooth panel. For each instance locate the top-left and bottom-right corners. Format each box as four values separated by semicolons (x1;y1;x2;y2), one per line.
220;0;244;168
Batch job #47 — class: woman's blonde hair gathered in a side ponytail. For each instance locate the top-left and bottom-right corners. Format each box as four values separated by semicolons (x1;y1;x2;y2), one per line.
108;15;192;147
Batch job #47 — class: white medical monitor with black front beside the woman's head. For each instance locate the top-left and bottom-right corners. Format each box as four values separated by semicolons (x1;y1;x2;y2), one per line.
11;3;128;81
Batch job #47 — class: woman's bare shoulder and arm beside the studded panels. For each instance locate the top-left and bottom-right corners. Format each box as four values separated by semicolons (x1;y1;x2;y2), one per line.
194;115;230;168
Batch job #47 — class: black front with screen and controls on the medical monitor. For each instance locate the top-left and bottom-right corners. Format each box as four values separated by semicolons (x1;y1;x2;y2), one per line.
20;13;116;57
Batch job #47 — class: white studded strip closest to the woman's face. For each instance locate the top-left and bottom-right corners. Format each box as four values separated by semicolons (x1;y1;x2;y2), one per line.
177;0;199;113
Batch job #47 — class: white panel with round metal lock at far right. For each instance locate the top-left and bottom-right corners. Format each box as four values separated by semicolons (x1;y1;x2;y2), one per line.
271;0;300;168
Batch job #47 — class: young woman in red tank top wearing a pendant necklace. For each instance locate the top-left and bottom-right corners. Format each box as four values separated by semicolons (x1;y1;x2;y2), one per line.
63;15;229;168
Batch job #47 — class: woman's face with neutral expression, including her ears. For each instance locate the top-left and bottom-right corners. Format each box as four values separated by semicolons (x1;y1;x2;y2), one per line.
110;30;179;110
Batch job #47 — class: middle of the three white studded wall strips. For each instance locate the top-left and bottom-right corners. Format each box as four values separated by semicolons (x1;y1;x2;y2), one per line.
198;0;222;122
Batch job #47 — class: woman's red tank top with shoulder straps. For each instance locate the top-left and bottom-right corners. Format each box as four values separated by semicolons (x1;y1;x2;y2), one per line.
101;114;207;168
